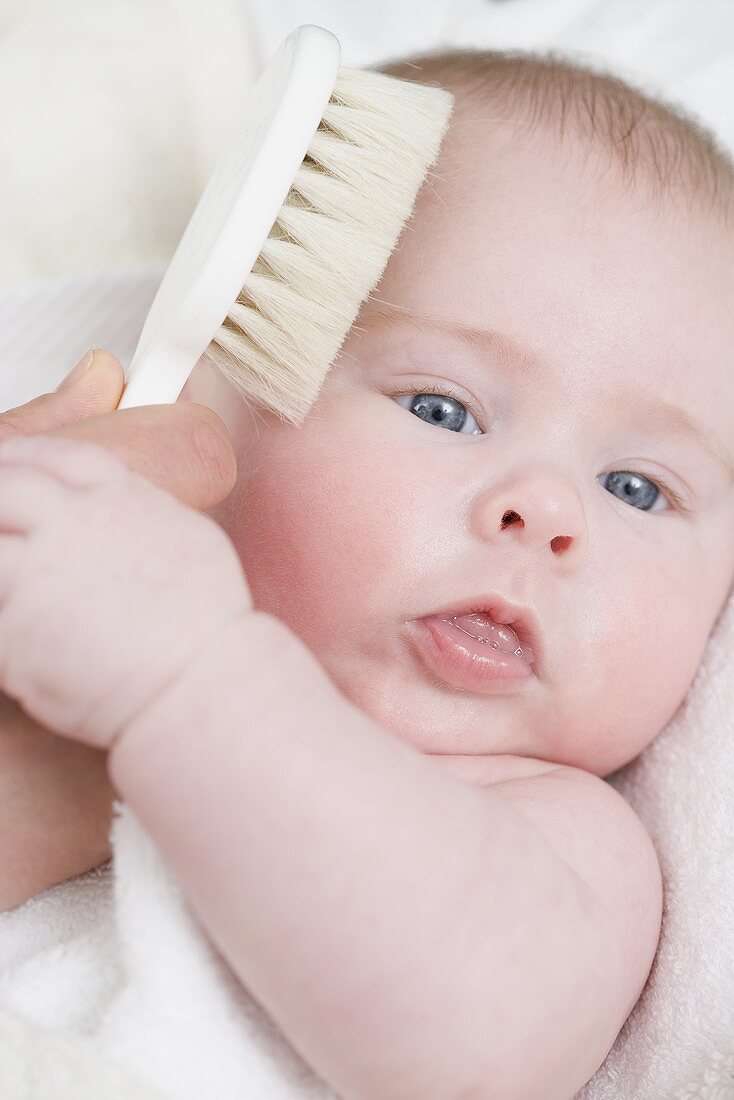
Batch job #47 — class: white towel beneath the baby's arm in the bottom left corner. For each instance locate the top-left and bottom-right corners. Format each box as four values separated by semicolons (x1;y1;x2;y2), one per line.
0;804;335;1100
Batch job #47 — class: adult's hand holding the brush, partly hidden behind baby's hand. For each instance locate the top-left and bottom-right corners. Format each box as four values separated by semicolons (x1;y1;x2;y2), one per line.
0;349;237;911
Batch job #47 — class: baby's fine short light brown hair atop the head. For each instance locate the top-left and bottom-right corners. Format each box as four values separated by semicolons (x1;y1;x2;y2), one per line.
380;50;734;223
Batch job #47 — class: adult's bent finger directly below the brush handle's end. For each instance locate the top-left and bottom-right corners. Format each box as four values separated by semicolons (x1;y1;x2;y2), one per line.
50;403;237;512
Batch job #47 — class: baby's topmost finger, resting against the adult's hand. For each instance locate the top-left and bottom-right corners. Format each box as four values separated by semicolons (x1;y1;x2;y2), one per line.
0;436;130;488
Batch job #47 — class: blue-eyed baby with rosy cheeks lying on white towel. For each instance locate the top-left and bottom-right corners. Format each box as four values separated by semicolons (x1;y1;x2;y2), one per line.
0;47;734;1100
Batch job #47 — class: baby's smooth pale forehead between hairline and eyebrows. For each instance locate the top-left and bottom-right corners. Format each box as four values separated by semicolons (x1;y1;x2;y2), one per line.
369;118;734;462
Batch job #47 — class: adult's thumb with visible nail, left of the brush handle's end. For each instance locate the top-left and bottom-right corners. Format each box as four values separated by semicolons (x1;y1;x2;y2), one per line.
0;348;124;436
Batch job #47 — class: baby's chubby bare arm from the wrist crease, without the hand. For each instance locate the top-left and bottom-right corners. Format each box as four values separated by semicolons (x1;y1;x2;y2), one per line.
110;613;644;1100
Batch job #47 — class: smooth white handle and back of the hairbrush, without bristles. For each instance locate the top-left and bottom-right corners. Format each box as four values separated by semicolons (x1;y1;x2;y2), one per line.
118;25;341;408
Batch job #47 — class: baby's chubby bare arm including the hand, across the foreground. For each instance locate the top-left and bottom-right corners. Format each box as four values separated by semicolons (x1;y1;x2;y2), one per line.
0;437;651;1100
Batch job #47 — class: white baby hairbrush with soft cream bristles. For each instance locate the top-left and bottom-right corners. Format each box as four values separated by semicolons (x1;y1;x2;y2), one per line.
119;25;452;424
